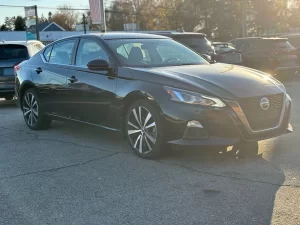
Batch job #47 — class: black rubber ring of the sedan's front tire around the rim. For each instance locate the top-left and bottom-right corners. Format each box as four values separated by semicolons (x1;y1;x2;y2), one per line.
124;100;164;159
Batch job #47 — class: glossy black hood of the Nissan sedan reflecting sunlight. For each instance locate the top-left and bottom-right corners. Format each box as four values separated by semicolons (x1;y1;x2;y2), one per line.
126;63;284;98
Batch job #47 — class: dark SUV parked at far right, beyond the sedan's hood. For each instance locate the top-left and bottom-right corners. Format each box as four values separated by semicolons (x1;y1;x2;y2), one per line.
230;37;299;75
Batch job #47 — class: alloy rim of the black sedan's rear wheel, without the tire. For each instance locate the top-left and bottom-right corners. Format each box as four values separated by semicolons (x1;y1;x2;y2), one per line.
23;93;39;127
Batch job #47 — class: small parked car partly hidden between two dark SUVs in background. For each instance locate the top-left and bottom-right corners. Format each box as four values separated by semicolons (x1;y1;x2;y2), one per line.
212;42;243;65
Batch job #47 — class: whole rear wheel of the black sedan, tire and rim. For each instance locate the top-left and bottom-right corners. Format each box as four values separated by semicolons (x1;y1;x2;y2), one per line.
22;88;52;130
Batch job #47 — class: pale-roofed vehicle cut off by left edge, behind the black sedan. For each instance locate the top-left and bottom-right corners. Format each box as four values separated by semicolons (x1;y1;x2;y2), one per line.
0;41;44;100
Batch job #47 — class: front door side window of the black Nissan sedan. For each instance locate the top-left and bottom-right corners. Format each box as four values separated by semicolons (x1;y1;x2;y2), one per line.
75;39;109;67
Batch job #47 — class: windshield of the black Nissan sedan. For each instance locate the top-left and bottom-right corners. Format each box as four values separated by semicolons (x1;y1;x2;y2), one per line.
107;39;209;67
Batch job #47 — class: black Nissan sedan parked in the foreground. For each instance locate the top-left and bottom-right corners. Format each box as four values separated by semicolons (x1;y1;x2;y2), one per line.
16;33;292;158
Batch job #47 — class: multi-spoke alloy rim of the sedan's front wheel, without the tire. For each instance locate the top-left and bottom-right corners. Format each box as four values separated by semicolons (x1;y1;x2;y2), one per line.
127;106;157;154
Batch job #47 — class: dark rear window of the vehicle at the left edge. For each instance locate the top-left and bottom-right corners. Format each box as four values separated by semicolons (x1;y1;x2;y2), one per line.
0;45;28;60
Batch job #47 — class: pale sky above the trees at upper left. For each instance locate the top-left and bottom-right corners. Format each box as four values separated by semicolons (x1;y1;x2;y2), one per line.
0;0;111;24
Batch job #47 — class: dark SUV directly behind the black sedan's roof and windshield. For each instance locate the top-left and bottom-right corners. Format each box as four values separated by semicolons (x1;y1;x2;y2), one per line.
151;32;219;61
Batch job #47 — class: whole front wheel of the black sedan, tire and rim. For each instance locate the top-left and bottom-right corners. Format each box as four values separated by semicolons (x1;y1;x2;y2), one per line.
125;100;166;159
